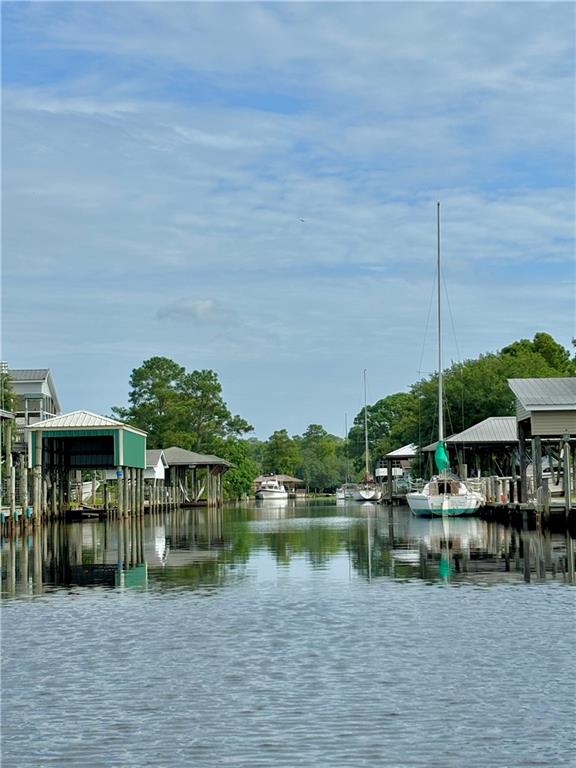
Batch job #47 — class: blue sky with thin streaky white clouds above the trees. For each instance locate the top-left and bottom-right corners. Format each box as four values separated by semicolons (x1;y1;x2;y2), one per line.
1;2;576;439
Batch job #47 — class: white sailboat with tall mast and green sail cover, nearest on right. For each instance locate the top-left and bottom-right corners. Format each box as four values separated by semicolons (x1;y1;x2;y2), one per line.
406;203;484;517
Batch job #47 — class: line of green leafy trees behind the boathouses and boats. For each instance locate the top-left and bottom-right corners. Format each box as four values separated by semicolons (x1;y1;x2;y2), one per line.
112;333;576;499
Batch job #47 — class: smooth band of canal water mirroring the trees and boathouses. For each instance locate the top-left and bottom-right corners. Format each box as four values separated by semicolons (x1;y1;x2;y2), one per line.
0;500;575;597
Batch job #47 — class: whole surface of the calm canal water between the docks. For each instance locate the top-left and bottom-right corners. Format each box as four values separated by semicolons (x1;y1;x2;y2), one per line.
1;501;576;768
